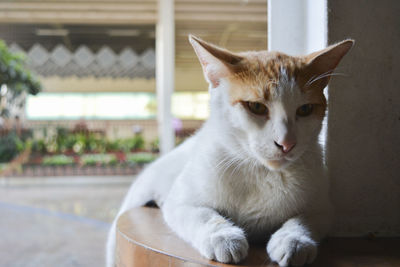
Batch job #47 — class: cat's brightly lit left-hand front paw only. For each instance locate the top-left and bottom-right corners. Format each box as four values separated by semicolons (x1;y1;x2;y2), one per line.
199;226;249;263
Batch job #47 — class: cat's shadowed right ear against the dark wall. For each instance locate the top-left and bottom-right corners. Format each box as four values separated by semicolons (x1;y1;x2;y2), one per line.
305;39;354;90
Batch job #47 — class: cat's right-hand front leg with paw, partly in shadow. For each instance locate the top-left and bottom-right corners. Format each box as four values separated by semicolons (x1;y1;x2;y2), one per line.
267;213;330;266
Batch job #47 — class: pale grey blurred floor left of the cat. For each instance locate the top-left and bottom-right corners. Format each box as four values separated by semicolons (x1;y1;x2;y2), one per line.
0;177;133;267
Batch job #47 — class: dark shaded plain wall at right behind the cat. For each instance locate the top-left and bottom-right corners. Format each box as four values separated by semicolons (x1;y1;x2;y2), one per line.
327;0;400;235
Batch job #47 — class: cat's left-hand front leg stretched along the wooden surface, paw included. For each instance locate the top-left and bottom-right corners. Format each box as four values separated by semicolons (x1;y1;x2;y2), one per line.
162;205;249;263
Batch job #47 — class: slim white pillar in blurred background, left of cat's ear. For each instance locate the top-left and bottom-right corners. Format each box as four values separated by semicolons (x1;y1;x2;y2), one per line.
156;0;175;154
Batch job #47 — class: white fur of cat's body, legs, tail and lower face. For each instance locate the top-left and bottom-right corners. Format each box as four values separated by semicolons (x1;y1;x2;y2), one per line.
107;68;330;266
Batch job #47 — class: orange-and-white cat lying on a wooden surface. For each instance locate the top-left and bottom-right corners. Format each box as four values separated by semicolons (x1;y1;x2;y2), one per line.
107;35;354;266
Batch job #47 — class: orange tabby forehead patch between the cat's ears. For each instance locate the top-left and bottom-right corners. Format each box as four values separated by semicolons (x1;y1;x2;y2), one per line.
228;51;305;100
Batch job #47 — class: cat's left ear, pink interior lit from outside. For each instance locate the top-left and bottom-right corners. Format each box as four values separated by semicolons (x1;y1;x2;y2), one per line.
189;35;243;87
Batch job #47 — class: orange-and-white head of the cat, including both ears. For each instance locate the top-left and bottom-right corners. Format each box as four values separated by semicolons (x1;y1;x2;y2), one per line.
189;36;354;170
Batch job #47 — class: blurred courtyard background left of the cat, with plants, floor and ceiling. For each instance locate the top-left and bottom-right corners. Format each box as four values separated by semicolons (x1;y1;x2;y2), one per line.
0;0;267;266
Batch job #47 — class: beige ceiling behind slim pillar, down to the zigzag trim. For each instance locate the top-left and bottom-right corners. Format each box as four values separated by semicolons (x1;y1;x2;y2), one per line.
0;0;267;90
